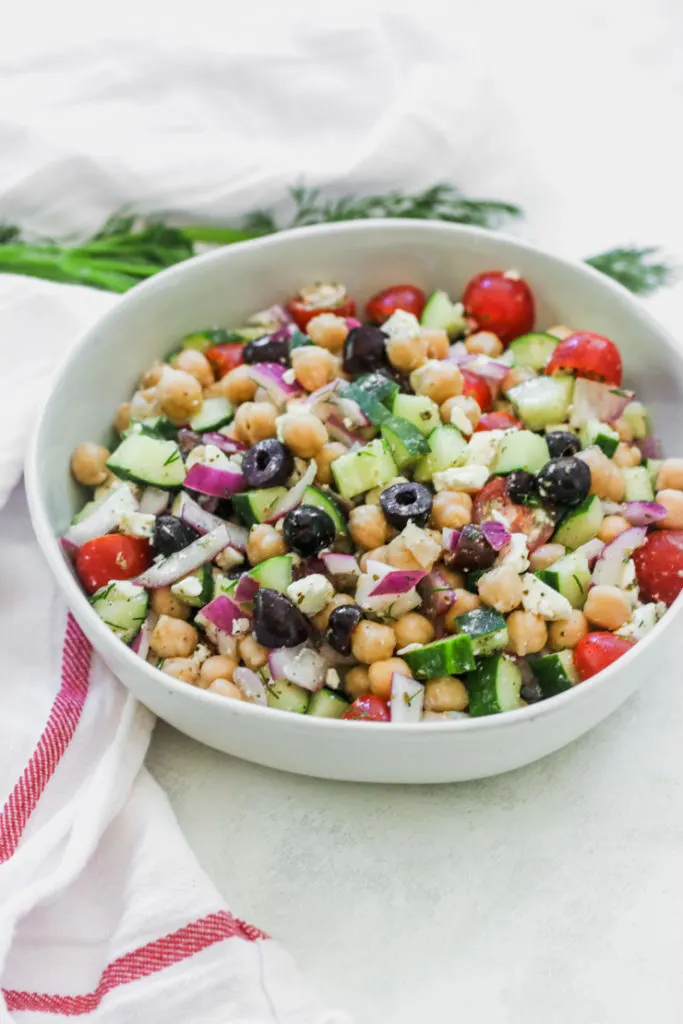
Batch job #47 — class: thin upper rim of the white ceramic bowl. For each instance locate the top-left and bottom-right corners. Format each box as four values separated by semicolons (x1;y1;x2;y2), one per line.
25;218;683;736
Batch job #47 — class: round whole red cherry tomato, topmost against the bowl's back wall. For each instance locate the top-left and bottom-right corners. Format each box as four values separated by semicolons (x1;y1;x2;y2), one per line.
463;270;535;345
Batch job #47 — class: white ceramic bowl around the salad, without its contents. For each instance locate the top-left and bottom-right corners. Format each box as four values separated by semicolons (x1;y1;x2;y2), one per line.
27;221;683;782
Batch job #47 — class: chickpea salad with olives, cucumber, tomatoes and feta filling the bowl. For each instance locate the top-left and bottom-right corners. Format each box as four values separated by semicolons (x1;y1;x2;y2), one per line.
61;270;683;723
